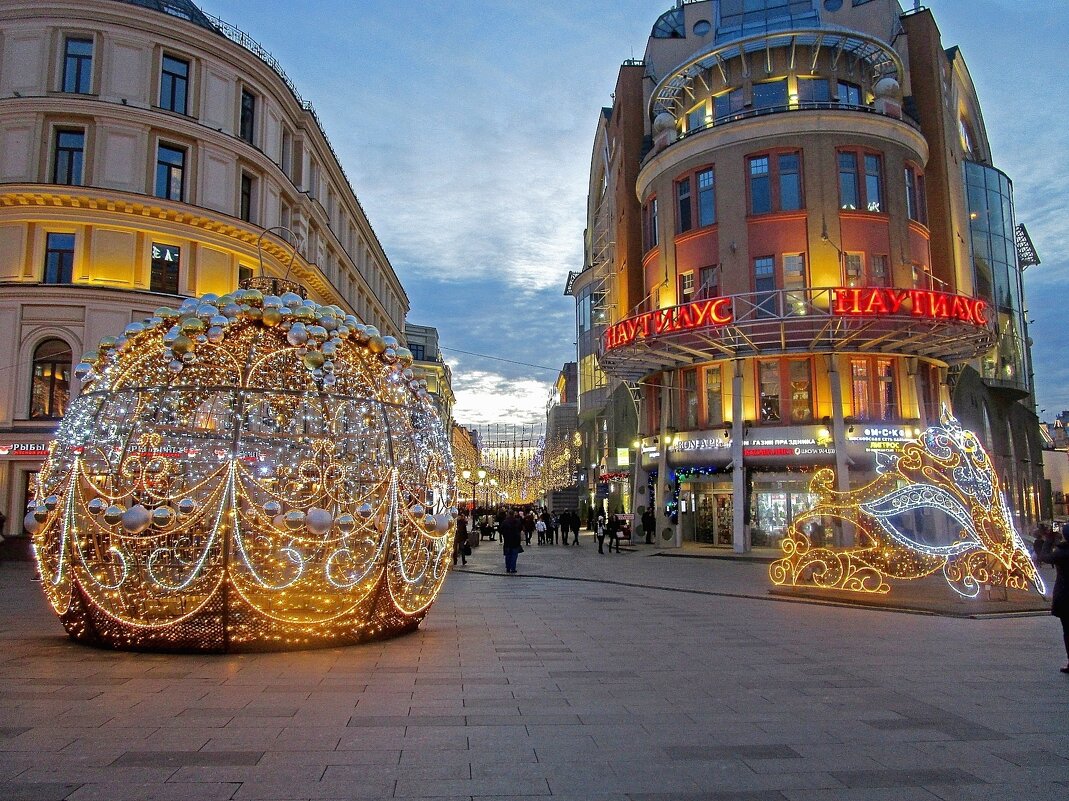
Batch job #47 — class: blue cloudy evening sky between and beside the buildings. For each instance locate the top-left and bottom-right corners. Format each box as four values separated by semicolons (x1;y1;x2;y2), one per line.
200;0;1069;425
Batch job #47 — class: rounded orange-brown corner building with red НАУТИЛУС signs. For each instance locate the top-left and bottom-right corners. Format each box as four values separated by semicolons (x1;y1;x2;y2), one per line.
585;0;1042;552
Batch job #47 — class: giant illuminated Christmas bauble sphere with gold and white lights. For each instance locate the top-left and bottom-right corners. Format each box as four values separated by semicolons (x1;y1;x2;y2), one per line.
26;289;456;651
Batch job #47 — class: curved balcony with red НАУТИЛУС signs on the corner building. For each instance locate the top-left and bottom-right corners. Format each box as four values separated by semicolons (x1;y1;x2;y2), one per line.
600;287;997;381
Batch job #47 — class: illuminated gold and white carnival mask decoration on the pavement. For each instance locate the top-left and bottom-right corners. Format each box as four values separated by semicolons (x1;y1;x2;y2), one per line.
769;409;1045;598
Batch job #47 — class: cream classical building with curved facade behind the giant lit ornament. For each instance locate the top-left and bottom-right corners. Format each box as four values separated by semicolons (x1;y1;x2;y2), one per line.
0;0;408;533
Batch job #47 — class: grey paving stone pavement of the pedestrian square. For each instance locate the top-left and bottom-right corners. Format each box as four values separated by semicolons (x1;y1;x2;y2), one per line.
0;534;1069;801
